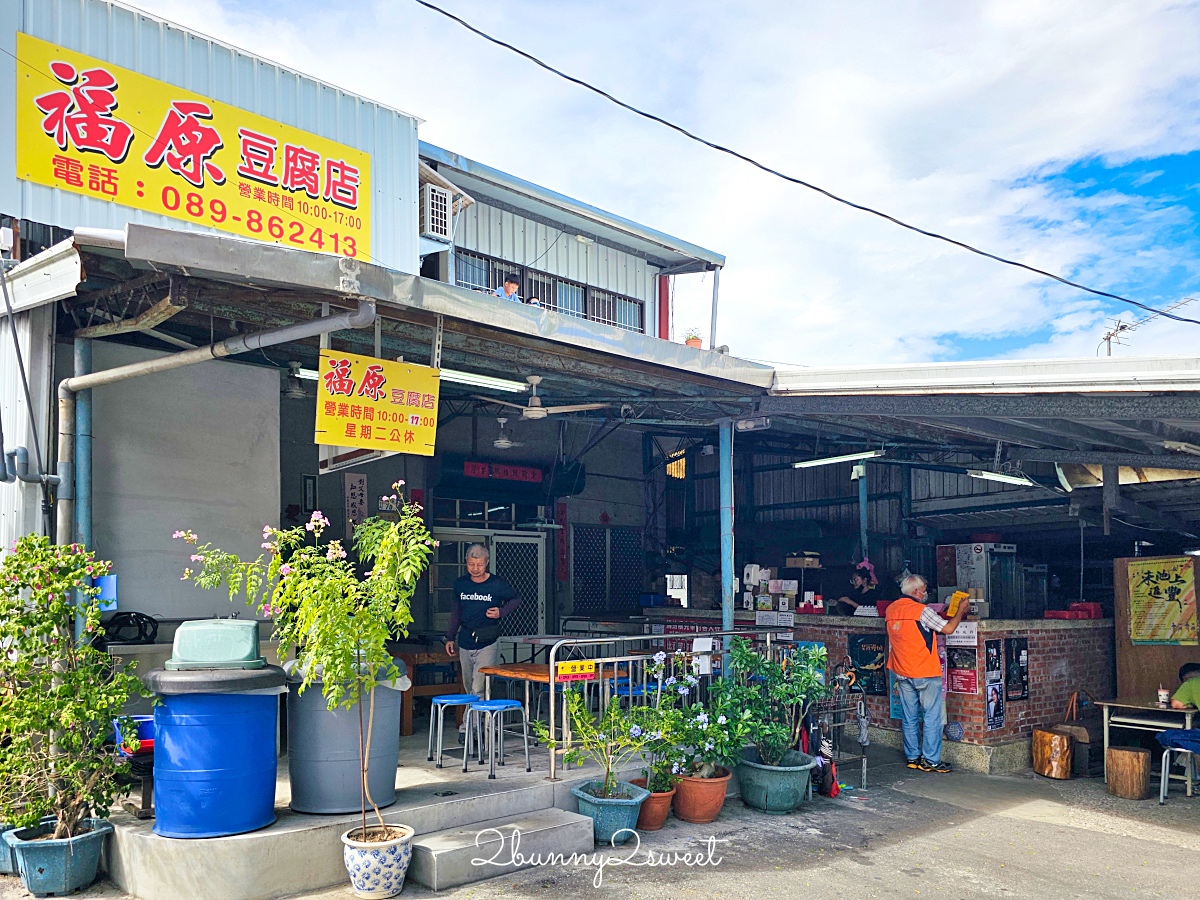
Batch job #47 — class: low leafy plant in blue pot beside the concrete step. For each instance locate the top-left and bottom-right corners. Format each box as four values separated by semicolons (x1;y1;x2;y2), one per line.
533;690;650;846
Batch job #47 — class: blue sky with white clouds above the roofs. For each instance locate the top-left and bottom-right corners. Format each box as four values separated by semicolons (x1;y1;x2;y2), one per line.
132;0;1200;365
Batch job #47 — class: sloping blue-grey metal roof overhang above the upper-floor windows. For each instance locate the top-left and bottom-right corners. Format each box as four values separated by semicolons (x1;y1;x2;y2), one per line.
420;140;725;271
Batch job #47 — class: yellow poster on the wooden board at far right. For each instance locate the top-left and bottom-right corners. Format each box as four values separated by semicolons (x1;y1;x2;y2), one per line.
1129;557;1200;646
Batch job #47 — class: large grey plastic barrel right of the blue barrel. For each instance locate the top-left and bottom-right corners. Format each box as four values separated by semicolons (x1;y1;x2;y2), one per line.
288;677;401;812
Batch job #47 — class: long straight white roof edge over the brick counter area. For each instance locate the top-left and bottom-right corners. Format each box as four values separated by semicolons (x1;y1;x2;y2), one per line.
760;391;1200;421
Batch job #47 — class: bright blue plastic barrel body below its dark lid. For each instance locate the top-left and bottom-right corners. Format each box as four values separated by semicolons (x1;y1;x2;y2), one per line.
154;694;278;838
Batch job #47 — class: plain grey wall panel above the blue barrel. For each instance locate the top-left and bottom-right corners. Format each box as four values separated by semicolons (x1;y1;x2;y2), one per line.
88;341;280;618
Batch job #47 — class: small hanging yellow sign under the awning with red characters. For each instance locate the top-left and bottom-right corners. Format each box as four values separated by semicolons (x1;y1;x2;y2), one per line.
316;350;442;456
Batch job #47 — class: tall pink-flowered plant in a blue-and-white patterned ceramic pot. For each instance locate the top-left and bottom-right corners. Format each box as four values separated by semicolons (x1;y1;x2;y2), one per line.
176;481;436;898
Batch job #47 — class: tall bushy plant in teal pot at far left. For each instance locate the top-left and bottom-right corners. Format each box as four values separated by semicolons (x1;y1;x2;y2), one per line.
0;535;148;896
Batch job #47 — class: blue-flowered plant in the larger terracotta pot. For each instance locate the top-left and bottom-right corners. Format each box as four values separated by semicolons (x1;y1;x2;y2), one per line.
662;673;750;824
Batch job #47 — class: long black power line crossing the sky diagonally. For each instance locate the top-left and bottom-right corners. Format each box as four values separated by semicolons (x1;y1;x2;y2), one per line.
415;0;1200;325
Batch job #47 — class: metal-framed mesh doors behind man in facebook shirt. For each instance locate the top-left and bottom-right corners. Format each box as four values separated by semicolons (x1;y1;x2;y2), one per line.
430;528;547;635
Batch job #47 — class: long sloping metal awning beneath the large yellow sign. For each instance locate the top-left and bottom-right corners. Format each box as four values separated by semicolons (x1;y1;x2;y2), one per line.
2;224;774;422
